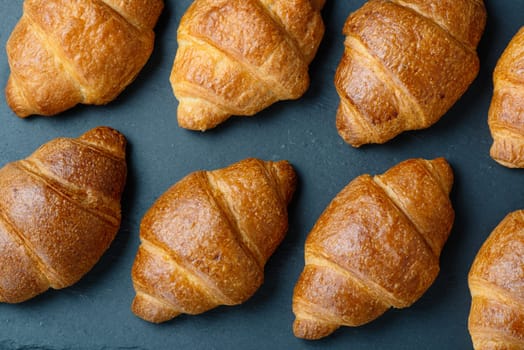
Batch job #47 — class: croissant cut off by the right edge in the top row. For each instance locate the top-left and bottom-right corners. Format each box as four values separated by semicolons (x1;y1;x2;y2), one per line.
488;27;524;168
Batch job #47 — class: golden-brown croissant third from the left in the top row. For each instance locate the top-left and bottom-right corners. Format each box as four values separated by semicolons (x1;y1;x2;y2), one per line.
335;0;486;147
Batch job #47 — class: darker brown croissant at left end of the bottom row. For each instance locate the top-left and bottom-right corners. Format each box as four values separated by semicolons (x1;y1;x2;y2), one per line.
0;127;126;303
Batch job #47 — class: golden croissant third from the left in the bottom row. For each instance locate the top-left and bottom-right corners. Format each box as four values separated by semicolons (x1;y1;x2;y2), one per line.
293;158;454;339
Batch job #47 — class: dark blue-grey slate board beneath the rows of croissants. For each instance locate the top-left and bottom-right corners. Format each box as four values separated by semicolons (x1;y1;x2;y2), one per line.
0;0;524;350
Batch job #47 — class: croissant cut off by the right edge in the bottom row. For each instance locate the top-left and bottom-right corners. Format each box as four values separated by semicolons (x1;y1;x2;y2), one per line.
468;210;524;350
